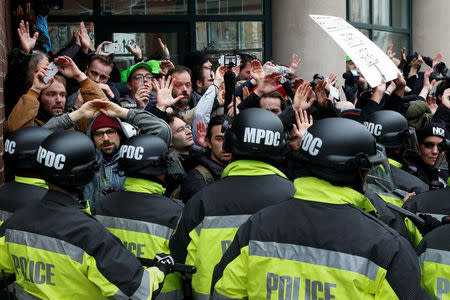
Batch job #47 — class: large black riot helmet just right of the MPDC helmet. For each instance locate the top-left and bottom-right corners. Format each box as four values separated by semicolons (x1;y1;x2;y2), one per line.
297;118;386;187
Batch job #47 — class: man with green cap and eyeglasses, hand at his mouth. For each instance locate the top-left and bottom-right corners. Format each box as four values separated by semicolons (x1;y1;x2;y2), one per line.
120;62;153;109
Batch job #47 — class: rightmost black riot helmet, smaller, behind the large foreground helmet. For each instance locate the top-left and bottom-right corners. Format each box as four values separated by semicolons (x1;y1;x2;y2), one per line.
364;110;417;150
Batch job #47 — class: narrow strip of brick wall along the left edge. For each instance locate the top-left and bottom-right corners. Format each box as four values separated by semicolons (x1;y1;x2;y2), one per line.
0;0;12;184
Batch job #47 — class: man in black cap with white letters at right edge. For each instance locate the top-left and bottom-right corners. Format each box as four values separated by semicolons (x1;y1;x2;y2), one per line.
408;123;448;189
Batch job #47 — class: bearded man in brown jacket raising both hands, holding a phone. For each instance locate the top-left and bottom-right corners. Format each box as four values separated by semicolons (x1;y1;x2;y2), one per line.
4;56;105;133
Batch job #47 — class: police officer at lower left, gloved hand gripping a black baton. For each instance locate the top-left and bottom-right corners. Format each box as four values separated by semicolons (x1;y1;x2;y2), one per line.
0;131;173;299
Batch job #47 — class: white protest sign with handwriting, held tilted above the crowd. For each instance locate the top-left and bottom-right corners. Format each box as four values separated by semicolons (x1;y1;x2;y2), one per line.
309;15;399;87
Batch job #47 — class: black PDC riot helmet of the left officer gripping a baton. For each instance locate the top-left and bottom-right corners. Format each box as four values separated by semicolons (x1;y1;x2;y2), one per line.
36;130;101;187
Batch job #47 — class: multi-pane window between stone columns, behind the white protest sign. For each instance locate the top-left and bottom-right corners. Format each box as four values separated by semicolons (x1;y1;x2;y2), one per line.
347;0;411;58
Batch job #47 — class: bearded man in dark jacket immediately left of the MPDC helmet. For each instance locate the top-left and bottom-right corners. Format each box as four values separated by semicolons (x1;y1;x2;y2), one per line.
180;115;231;202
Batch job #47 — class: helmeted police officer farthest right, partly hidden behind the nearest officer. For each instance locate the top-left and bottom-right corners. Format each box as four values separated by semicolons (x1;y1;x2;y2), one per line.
364;110;429;197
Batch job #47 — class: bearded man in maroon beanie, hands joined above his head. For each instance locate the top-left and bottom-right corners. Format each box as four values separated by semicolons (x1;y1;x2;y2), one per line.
45;99;172;209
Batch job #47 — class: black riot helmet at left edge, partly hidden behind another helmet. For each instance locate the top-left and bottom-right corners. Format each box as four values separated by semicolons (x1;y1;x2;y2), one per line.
3;127;52;174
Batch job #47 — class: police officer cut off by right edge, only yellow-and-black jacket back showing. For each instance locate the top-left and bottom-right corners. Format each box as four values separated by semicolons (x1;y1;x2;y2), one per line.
417;221;450;300
